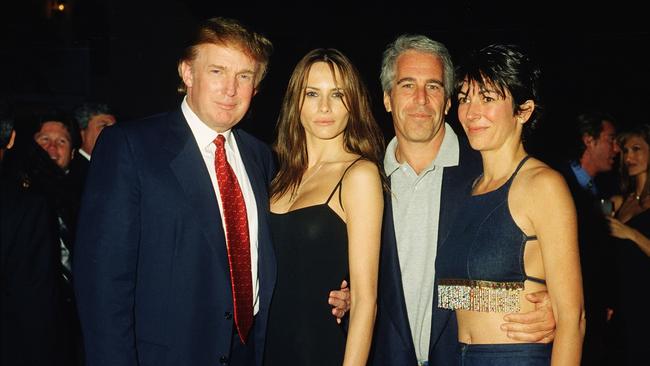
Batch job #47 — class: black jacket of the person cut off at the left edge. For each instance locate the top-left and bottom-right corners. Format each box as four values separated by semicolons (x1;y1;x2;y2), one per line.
0;177;61;365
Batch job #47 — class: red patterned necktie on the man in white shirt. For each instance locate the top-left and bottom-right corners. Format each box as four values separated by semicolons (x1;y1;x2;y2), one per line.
214;135;253;344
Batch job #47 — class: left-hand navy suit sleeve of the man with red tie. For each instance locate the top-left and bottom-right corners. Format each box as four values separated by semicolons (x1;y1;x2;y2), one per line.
74;126;140;366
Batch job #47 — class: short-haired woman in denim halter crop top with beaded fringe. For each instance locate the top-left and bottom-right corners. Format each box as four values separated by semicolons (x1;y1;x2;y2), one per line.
436;45;585;366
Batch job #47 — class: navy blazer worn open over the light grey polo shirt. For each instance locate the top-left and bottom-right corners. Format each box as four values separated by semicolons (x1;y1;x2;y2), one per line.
370;135;481;366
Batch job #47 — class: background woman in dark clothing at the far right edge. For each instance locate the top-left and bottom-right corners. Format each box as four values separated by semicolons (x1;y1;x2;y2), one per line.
607;124;650;365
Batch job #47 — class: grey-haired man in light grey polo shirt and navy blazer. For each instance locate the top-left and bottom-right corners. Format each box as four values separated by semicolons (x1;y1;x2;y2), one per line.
370;35;555;366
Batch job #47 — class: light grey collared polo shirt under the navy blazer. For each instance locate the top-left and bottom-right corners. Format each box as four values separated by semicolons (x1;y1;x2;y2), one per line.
384;123;459;362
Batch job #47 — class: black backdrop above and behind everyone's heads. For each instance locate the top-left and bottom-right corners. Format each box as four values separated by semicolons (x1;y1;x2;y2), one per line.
0;0;650;160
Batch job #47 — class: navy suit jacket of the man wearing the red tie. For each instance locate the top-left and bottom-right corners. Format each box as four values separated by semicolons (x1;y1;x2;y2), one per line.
74;109;276;366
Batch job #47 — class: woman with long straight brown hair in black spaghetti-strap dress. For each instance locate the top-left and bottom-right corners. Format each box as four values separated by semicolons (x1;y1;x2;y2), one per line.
264;49;384;366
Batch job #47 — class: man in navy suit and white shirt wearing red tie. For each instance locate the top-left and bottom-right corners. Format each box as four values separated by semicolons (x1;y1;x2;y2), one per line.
74;18;276;366
